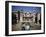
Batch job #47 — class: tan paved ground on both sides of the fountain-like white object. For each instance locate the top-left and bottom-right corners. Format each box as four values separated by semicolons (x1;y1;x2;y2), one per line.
12;23;41;31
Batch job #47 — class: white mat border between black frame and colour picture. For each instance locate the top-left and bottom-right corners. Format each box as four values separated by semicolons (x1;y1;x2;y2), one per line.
9;3;44;34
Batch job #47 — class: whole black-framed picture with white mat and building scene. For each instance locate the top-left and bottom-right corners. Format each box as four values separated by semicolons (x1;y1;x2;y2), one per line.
5;1;45;35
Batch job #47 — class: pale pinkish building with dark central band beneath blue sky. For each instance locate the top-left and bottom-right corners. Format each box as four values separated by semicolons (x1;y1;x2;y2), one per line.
12;12;40;23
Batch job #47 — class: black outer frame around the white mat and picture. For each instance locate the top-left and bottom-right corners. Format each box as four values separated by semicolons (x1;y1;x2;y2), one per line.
5;1;45;36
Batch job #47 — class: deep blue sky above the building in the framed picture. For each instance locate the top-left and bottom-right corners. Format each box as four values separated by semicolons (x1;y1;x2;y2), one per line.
12;6;41;13
